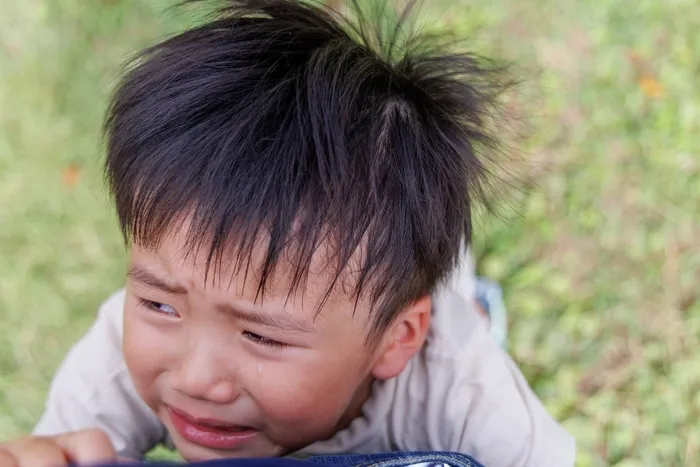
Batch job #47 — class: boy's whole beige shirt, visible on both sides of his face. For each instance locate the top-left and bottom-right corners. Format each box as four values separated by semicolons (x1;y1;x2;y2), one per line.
34;263;575;467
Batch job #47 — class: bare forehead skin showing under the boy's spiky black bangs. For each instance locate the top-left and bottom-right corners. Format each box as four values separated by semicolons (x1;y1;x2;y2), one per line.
135;218;372;332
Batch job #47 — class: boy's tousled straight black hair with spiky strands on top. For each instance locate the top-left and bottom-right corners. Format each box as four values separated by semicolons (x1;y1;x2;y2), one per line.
105;0;506;337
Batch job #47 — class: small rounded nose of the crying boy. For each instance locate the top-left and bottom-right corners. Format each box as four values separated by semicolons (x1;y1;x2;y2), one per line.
170;347;240;404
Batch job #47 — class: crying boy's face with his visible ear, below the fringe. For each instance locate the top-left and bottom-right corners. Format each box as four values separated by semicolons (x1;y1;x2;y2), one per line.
123;227;430;460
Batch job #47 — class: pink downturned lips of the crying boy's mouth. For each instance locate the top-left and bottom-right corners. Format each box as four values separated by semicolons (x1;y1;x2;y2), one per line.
168;407;258;450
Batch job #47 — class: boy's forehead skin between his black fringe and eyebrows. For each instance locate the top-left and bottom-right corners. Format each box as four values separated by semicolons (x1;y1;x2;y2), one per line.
131;224;370;314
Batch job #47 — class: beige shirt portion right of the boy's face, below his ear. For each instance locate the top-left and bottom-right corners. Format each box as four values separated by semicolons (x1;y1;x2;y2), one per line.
305;275;575;467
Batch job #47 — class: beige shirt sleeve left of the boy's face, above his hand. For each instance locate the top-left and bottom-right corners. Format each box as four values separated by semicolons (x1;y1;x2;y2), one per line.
33;291;165;459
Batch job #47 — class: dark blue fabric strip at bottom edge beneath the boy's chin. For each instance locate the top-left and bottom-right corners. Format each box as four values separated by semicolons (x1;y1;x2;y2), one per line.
86;452;484;467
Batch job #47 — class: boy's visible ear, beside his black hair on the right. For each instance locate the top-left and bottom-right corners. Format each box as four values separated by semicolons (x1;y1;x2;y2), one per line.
372;295;432;379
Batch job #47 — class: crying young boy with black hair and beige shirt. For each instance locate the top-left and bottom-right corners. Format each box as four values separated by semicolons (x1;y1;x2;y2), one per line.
0;0;575;467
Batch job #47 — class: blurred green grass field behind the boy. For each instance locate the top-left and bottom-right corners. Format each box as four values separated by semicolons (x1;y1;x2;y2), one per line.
0;0;700;467
